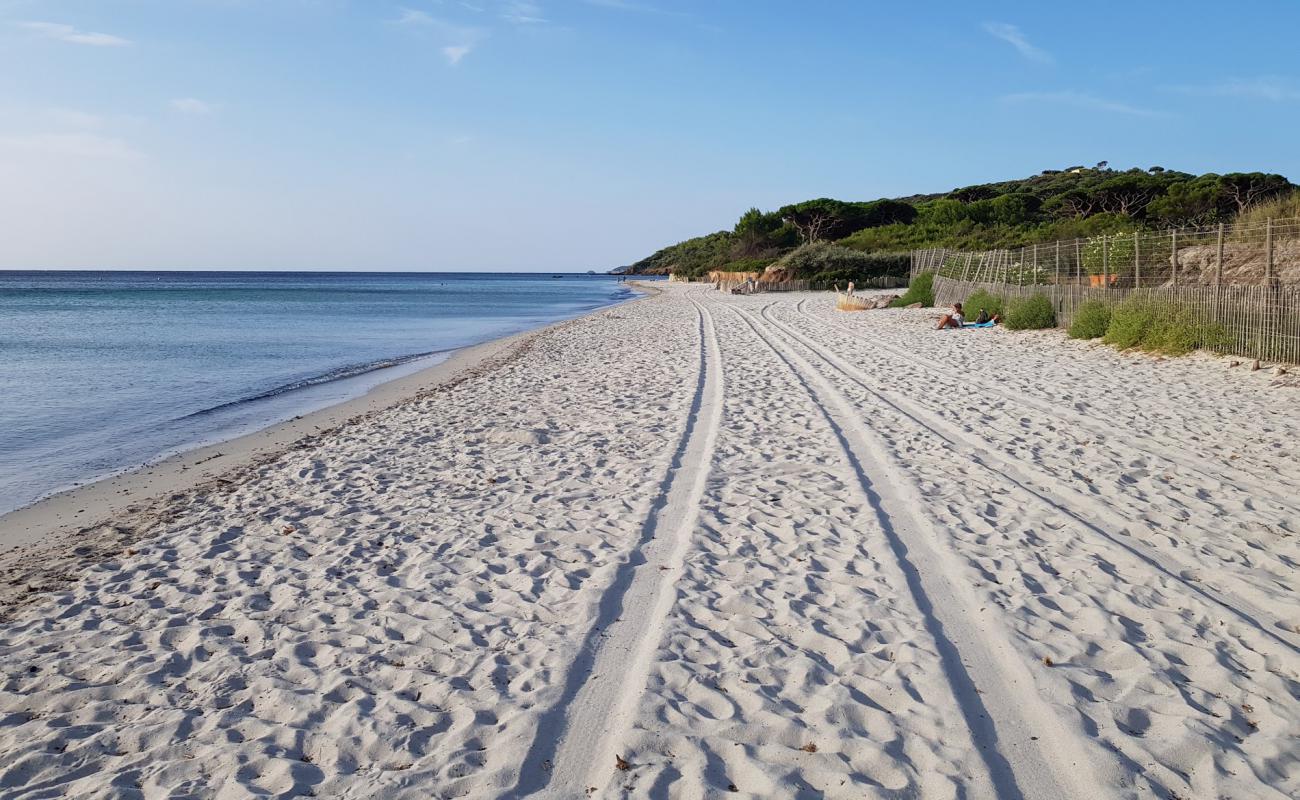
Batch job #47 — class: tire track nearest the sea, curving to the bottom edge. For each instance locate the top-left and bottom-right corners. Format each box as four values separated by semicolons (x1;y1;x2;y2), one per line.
510;298;723;800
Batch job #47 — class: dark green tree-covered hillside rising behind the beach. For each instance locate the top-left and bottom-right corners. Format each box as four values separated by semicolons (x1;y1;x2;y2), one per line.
620;161;1297;280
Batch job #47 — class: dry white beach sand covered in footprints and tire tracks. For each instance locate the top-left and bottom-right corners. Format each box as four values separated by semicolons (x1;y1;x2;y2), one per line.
0;286;1300;799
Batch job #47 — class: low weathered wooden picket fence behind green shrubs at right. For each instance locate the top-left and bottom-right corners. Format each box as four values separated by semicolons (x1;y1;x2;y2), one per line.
935;276;1300;364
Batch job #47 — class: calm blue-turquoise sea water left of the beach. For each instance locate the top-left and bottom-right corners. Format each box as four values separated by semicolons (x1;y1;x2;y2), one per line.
0;272;632;513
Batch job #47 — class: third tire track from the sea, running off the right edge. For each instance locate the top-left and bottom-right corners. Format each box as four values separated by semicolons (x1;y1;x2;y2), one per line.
762;306;1300;652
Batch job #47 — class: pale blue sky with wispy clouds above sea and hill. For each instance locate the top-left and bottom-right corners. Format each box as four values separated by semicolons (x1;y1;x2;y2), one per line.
0;0;1300;271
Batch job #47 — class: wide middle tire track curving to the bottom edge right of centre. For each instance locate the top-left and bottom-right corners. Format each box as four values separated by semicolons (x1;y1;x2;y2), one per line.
729;307;1104;800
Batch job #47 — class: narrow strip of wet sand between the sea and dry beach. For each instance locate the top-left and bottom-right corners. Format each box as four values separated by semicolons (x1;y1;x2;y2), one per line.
0;281;658;559
